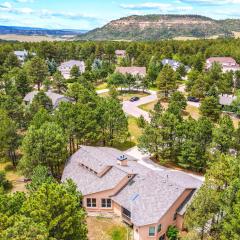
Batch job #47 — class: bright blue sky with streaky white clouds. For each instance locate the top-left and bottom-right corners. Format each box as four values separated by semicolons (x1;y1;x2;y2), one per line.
0;0;240;30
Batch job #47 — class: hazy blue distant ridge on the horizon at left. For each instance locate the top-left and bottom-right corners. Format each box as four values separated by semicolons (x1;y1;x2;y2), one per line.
0;26;87;36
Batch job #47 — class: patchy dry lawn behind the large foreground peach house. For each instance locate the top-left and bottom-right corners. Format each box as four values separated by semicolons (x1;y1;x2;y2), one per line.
87;217;130;240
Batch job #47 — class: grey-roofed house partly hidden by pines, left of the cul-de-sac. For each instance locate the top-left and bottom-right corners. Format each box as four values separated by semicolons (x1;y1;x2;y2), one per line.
23;91;72;109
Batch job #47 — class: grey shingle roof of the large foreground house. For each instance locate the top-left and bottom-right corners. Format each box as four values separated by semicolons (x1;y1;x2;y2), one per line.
62;146;202;226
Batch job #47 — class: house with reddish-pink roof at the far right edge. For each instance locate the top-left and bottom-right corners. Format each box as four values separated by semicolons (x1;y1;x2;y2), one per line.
206;57;240;72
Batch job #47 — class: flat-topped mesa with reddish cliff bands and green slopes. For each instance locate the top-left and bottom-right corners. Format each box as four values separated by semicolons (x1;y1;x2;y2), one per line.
78;15;240;41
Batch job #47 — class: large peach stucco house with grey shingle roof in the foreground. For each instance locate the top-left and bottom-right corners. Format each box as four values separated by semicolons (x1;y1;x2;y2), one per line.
62;146;202;240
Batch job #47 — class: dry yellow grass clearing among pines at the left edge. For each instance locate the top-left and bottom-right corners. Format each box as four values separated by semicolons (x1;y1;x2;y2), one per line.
0;162;26;192
